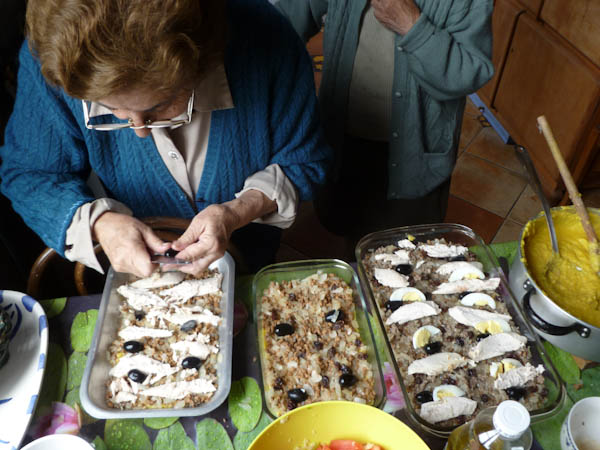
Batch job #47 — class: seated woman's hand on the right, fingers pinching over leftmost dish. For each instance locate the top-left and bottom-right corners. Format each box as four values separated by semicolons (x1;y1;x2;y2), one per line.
162;204;241;275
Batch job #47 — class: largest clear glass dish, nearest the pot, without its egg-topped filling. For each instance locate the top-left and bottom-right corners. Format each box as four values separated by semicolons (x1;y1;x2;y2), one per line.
356;224;565;438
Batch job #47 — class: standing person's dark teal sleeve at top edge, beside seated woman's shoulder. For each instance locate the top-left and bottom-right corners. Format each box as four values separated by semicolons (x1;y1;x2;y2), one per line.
275;0;329;42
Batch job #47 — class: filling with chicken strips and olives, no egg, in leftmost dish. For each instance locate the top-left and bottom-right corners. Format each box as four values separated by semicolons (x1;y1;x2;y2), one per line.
106;270;223;409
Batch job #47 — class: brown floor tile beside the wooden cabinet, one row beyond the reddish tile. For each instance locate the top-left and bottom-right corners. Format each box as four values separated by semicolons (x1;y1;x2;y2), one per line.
450;152;526;217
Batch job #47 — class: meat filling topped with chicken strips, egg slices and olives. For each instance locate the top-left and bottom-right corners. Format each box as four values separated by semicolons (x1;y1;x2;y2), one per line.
361;235;548;427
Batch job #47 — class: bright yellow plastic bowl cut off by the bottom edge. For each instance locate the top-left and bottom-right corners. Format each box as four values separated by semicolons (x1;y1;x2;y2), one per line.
248;401;429;450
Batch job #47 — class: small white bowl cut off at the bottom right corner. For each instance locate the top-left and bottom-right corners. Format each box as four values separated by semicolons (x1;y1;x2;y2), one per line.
560;397;600;450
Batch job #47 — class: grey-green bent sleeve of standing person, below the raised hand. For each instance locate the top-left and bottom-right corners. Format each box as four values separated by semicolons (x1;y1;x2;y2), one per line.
399;0;494;101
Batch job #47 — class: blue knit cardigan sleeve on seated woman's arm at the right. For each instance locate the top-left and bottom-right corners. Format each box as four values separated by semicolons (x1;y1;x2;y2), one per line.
269;5;333;200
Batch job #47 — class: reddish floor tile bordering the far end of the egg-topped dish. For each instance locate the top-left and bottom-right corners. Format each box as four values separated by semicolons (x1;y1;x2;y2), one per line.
444;195;503;243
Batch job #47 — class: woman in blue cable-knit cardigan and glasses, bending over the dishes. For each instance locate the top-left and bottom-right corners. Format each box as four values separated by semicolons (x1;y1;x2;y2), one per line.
0;0;330;276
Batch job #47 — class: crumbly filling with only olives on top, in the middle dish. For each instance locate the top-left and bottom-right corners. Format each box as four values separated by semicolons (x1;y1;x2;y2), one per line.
259;272;375;416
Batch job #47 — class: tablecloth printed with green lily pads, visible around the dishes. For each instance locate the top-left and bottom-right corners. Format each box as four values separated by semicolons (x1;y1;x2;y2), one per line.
23;242;600;450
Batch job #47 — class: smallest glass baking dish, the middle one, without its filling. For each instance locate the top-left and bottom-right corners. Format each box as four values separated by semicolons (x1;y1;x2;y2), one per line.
252;259;386;418
